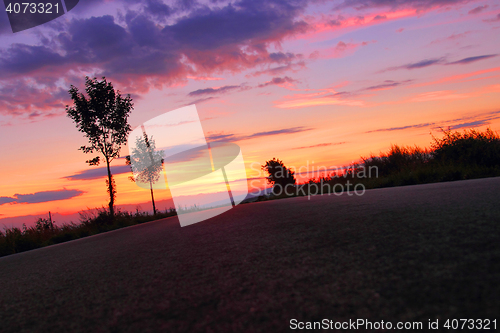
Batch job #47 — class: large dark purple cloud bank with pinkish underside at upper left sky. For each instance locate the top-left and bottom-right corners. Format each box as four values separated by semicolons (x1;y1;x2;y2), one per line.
0;0;309;115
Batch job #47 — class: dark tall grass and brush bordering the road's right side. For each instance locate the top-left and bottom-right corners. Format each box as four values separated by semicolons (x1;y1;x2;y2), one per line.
268;128;500;197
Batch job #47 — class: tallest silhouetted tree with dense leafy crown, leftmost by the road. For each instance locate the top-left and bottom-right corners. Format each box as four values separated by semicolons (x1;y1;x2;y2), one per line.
66;76;134;218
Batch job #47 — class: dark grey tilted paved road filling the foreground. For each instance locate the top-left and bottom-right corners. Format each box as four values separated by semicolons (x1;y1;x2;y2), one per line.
0;178;500;332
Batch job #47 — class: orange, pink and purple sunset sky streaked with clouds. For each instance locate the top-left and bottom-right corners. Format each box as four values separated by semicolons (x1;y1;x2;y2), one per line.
0;0;500;228
